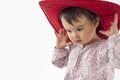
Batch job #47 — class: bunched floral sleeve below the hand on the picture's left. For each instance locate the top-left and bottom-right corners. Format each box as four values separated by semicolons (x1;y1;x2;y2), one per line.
52;48;69;68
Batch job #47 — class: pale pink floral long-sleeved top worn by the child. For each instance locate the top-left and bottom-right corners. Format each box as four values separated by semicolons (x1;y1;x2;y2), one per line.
52;33;120;80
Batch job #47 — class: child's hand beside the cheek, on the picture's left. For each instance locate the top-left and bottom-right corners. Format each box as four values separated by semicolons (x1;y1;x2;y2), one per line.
55;29;71;49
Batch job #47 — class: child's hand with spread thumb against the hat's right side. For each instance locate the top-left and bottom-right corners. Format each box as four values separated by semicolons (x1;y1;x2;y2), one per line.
100;13;118;37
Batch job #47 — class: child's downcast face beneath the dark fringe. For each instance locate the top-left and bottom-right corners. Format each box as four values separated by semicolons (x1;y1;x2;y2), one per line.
61;15;99;45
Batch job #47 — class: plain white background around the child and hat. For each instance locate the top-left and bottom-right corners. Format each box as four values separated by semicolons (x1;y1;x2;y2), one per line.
0;0;120;80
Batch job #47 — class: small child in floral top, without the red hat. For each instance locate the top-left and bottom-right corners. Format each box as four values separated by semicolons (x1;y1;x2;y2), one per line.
39;0;120;80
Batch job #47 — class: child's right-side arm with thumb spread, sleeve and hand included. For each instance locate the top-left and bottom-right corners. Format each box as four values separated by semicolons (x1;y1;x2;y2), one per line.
100;13;120;68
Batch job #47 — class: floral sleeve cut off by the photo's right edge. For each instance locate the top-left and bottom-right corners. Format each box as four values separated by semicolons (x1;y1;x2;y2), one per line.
108;33;120;69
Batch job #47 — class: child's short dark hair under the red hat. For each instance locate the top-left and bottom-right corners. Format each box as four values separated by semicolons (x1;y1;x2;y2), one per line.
59;7;98;25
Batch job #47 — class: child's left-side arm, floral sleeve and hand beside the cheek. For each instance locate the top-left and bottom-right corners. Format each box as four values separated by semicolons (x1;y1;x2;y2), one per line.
52;29;72;68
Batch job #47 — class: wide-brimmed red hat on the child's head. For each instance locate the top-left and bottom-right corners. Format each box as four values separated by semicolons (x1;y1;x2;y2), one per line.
39;0;120;39
